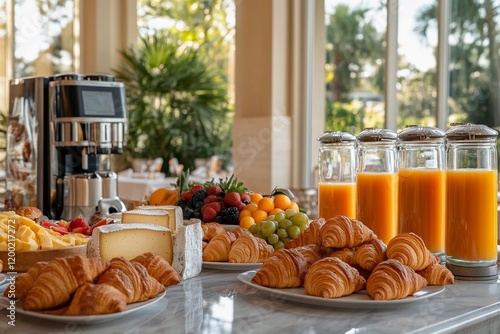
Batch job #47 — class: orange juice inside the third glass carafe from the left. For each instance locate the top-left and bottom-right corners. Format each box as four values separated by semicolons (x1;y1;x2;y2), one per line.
398;169;445;255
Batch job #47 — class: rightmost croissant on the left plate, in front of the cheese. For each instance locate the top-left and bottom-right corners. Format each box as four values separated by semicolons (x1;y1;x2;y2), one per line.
130;252;181;286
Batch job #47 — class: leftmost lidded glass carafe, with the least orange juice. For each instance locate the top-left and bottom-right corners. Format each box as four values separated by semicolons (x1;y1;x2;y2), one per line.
318;131;357;219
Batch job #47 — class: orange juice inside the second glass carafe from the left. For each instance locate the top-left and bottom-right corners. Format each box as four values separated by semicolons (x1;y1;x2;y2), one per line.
356;173;397;244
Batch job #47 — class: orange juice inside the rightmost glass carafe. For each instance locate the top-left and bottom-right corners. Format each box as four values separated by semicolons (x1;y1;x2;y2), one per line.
446;169;498;262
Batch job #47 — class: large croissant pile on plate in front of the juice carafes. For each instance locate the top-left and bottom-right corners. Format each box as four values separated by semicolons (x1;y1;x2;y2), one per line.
252;216;454;300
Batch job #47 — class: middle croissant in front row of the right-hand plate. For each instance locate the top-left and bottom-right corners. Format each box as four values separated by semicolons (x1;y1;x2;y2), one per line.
304;257;366;298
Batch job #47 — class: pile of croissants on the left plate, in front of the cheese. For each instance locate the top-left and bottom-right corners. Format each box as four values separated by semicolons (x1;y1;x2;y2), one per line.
4;253;181;316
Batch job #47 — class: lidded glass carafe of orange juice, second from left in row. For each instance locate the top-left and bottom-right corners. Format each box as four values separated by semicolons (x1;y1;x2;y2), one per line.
356;129;398;244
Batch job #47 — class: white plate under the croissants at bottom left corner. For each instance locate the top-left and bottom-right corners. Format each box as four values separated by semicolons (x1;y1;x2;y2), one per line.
0;291;167;325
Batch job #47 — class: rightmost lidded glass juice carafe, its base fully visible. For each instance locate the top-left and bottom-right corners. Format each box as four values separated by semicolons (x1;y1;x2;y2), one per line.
445;124;498;280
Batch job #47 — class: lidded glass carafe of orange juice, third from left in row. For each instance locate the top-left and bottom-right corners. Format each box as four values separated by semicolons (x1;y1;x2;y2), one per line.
398;125;445;256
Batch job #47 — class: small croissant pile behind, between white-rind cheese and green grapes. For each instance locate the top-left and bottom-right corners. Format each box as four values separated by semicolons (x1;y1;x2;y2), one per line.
202;222;274;263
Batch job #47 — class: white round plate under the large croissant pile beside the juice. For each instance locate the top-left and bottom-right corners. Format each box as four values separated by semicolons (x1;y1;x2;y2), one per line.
238;270;445;309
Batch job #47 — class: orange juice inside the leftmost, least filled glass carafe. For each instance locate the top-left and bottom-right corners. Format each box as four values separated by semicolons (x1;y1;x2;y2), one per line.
318;182;356;219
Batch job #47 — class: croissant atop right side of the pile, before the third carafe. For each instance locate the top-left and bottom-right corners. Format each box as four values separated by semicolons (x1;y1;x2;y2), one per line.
386;232;437;271
